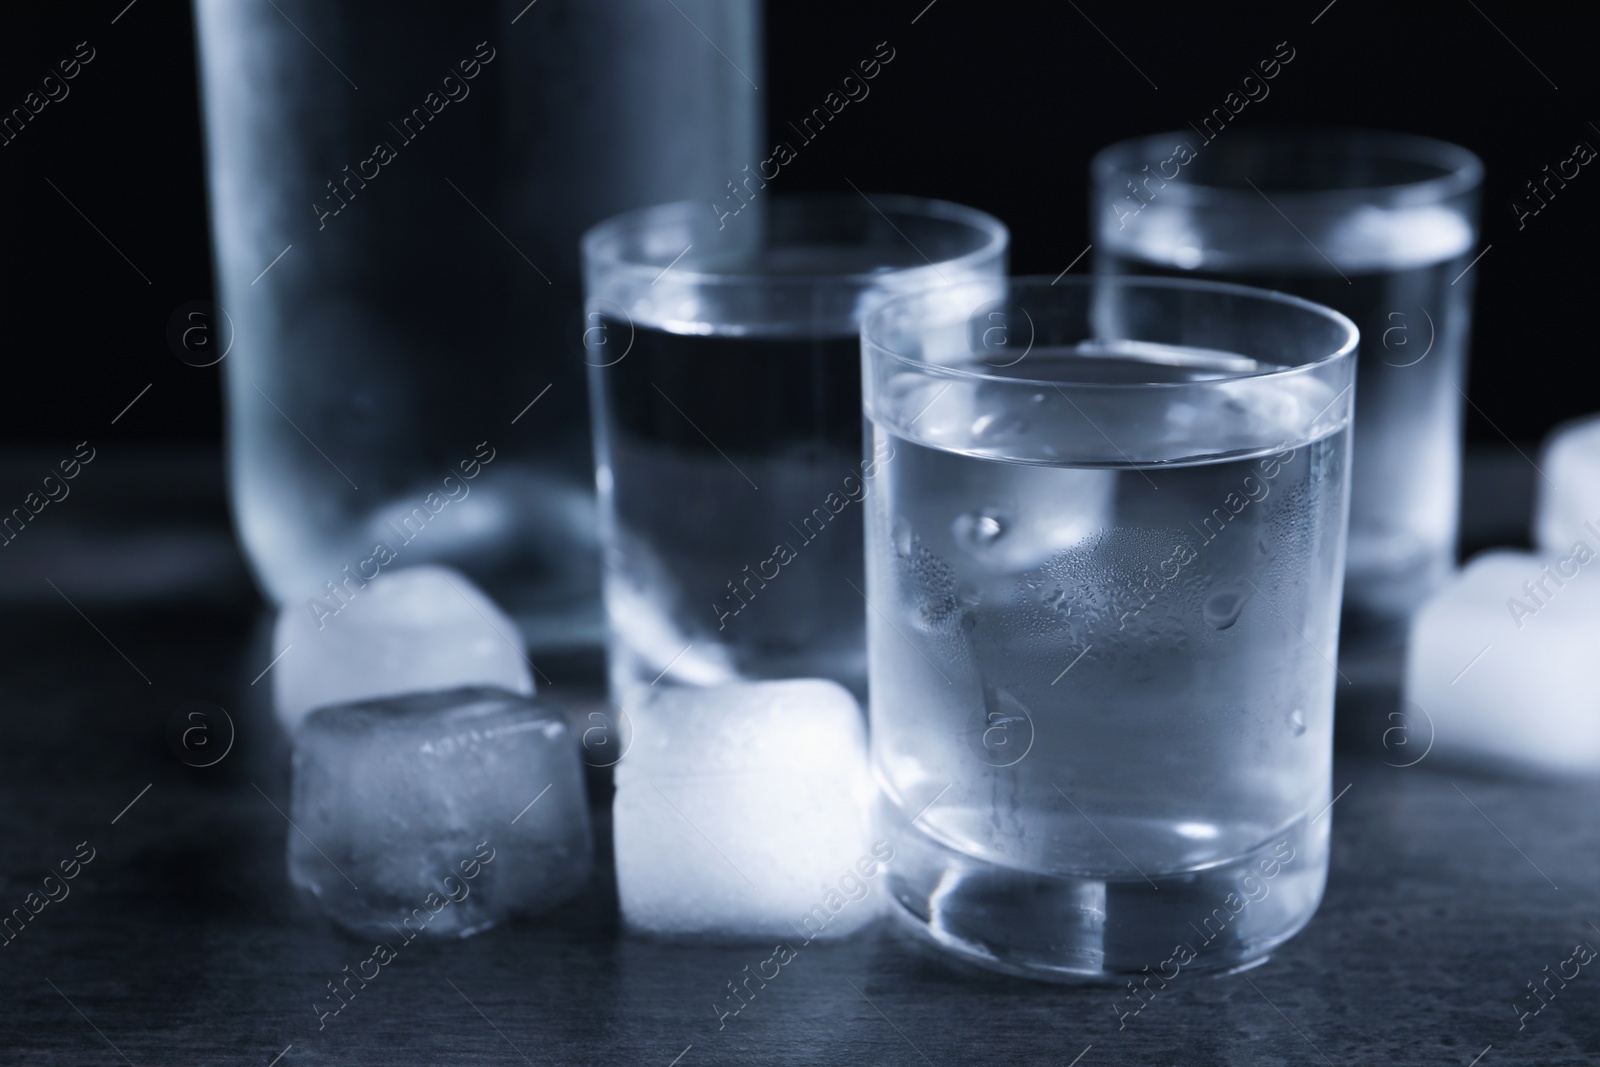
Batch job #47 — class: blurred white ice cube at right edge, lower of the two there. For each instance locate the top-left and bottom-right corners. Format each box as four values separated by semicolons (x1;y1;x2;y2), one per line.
1405;552;1600;773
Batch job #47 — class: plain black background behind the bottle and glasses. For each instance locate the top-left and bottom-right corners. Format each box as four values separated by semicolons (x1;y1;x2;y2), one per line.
0;0;1600;446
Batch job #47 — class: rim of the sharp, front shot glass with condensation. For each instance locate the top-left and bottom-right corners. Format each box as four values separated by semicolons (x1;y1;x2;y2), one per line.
861;274;1360;390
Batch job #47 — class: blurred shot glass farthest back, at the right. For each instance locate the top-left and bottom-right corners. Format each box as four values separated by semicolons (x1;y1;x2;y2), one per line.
1091;131;1483;656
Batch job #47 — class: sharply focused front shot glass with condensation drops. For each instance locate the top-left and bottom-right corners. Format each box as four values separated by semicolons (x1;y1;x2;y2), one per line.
862;277;1357;985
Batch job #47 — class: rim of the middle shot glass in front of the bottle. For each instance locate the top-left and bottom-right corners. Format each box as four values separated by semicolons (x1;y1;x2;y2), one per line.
581;190;1011;288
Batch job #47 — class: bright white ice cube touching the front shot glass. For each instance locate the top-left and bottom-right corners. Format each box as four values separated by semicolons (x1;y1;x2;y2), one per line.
613;678;891;947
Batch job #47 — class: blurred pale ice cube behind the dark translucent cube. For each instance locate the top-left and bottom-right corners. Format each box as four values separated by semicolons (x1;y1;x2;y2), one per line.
272;565;533;733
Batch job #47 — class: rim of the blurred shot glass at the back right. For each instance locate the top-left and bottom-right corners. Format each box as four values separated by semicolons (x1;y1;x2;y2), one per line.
1090;125;1483;208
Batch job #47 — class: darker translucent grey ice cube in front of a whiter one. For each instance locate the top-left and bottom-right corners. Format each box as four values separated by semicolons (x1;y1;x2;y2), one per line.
288;688;594;945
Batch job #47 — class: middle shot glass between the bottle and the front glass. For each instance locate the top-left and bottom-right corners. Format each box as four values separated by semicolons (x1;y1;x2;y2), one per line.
582;194;1008;701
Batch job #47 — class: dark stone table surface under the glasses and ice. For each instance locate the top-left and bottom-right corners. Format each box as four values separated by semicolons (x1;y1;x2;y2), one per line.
0;453;1600;1067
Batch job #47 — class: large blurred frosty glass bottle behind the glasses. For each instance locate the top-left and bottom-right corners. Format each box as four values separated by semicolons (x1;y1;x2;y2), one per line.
195;0;760;648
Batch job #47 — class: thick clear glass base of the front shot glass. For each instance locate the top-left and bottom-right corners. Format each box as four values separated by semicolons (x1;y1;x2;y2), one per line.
883;803;1331;985
